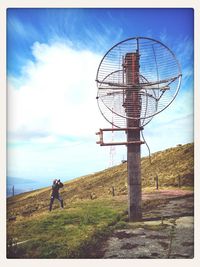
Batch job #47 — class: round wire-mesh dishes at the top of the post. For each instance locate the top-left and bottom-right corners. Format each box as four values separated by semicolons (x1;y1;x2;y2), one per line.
96;37;182;128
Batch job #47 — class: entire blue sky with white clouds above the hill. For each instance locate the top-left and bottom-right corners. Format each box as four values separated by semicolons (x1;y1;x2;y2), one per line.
7;8;194;184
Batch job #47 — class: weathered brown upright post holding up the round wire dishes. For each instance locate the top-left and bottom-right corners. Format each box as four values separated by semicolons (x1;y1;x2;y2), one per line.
125;52;142;221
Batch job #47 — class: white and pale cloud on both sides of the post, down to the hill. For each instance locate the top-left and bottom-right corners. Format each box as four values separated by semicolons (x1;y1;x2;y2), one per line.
8;42;193;181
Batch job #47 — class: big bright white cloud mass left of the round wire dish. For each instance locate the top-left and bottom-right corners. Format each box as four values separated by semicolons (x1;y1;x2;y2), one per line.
8;40;109;144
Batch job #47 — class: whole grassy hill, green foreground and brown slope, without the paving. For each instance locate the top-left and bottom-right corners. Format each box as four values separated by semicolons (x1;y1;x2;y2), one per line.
7;144;194;258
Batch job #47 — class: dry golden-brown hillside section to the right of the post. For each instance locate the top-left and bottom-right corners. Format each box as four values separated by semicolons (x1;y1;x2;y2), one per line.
142;143;194;186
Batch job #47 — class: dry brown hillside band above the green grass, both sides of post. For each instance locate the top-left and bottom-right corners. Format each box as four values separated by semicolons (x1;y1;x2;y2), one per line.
7;144;194;217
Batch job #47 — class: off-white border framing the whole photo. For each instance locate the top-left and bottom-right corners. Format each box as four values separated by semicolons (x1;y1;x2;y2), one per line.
0;0;200;267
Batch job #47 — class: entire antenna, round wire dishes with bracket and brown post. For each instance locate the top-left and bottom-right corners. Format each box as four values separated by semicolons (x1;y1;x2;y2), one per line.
96;37;182;221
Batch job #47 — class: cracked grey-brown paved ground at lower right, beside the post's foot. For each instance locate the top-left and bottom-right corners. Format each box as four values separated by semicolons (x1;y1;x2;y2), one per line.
102;190;194;259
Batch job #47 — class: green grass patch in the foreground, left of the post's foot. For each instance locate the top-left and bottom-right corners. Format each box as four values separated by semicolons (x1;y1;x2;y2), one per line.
7;199;126;258
